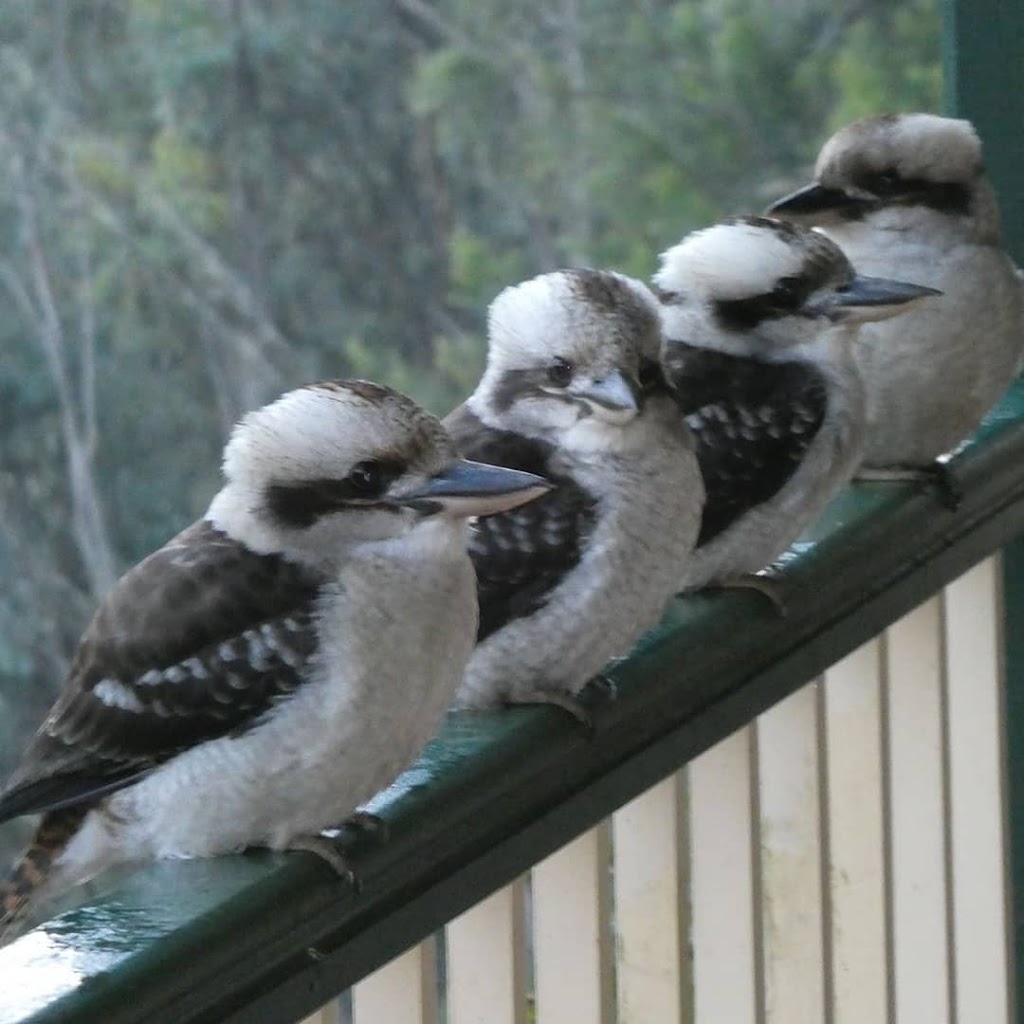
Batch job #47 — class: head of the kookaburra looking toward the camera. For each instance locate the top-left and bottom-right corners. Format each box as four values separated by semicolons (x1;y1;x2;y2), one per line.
469;269;660;440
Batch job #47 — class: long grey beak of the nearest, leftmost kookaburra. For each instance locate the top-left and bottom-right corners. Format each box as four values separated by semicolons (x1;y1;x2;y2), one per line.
392;459;554;518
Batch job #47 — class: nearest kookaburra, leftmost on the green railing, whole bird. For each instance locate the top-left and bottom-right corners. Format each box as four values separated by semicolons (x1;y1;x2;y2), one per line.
0;380;550;939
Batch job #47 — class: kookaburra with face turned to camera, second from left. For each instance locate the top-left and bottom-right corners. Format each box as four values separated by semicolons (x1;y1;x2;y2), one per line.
443;268;703;725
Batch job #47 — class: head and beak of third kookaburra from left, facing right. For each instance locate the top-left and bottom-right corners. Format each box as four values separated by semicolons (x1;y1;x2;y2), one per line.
654;217;939;357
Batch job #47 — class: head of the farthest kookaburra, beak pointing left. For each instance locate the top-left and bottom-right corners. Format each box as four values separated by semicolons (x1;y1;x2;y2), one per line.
768;114;998;231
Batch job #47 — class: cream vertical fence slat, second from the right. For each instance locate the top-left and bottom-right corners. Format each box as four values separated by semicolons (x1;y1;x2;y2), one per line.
884;597;950;1024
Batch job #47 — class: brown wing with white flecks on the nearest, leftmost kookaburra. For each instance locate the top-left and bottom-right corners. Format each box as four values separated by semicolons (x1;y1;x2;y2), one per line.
0;520;326;821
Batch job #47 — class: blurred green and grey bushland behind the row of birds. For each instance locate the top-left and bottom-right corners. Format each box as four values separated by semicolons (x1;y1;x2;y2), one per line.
0;0;941;858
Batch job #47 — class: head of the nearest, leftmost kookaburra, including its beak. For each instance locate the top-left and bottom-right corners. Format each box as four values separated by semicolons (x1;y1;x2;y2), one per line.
210;380;550;563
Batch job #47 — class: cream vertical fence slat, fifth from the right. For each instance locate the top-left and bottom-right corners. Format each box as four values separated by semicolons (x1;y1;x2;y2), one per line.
687;728;758;1024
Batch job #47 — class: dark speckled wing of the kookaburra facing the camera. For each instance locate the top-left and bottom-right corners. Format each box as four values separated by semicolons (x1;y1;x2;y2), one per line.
444;406;597;642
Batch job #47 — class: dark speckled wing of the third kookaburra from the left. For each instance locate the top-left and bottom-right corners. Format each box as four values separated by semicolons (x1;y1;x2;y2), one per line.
663;342;827;548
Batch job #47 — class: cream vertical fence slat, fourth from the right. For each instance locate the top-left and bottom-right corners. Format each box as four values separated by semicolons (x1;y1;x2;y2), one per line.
757;684;824;1024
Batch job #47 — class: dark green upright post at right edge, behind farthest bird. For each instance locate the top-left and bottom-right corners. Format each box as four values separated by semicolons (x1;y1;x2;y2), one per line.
943;0;1024;1024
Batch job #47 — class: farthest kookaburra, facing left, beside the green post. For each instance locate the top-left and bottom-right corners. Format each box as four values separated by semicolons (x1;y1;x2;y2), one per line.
768;114;1024;479
